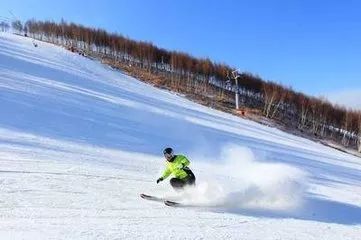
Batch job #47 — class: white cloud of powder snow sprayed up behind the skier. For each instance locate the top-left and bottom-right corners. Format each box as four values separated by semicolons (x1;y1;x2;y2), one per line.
185;145;307;211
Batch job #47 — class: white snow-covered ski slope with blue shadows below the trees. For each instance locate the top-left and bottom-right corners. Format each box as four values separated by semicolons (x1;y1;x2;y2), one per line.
0;33;361;240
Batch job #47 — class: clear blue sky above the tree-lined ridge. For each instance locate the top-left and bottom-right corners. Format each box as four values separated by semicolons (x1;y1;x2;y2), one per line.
0;0;361;109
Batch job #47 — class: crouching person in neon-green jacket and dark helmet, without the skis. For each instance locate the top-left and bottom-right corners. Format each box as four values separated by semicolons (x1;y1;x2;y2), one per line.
157;148;196;191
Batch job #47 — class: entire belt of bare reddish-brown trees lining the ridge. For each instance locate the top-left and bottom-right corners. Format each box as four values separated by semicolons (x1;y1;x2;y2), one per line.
12;20;361;151
